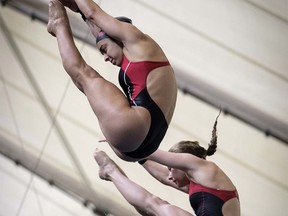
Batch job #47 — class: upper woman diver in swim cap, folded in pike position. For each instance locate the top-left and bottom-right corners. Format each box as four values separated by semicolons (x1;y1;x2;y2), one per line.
47;0;177;161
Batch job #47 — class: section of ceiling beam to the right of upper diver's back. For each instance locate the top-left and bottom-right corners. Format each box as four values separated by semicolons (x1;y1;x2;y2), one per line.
174;64;288;145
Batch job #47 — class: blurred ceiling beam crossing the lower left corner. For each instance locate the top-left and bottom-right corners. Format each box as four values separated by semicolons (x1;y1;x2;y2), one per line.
0;136;135;216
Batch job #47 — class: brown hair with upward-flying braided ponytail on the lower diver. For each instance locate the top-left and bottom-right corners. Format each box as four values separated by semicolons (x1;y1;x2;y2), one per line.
169;110;221;159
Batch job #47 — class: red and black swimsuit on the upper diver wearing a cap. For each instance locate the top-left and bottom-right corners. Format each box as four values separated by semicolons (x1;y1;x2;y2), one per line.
118;56;170;158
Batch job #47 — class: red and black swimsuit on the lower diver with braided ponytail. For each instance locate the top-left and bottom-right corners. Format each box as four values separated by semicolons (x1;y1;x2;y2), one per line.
189;181;239;216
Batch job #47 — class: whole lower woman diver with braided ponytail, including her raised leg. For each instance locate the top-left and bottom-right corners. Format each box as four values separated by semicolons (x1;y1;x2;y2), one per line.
94;117;240;216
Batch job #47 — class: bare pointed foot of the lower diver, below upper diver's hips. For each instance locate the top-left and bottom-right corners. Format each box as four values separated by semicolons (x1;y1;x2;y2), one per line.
94;149;126;181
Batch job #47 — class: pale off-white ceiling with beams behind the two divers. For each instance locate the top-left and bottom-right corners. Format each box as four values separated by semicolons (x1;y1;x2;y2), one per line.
0;0;288;216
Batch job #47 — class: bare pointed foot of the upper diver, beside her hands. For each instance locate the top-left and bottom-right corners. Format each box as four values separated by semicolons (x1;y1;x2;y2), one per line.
47;0;68;36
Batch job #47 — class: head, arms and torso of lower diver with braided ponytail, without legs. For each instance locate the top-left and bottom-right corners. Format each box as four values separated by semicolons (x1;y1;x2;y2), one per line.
143;114;240;216
